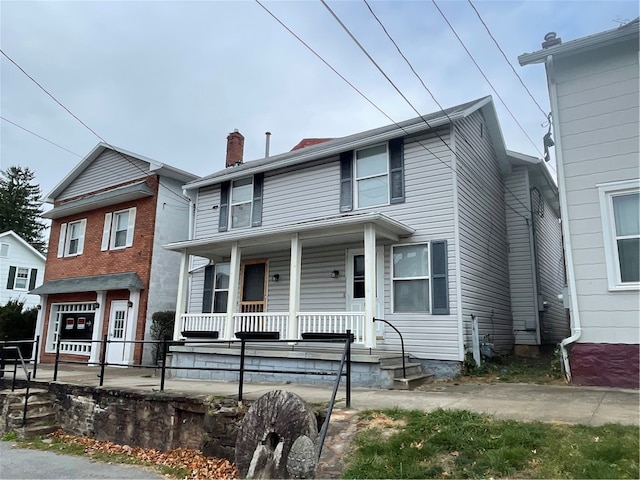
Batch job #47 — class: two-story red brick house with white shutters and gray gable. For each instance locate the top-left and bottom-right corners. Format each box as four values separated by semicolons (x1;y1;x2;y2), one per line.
31;143;196;365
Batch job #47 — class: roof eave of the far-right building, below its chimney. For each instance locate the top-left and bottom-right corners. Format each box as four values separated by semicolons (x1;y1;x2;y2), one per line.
518;18;640;66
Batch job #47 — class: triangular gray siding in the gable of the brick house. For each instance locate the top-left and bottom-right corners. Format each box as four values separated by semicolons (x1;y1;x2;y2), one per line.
56;150;149;201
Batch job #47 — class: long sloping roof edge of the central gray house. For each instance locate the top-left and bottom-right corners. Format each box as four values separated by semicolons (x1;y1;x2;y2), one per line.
184;96;509;190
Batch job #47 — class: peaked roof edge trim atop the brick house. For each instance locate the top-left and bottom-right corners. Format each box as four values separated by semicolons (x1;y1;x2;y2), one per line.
45;143;198;203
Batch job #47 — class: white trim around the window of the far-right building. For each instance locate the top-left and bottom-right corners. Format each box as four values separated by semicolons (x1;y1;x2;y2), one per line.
596;179;640;291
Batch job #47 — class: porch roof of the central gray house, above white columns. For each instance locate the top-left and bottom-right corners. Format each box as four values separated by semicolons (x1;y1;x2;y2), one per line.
164;212;415;258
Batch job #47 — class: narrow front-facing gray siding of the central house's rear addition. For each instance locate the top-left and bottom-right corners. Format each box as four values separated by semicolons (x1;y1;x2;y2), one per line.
505;167;536;345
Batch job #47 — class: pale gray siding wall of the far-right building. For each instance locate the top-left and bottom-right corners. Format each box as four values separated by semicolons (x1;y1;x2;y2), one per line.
554;39;640;343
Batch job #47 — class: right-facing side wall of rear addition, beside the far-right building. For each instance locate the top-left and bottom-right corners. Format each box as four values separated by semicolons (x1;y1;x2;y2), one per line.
532;182;570;344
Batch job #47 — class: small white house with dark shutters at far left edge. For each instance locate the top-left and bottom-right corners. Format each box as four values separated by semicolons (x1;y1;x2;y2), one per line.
0;235;45;308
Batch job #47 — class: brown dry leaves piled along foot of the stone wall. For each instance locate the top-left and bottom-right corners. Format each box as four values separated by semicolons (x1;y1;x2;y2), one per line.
50;430;238;480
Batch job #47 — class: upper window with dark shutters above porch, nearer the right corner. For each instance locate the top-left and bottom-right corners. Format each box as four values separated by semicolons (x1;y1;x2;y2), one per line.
340;138;404;212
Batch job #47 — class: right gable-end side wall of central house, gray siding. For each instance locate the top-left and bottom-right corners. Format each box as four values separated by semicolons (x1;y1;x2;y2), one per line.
455;112;513;352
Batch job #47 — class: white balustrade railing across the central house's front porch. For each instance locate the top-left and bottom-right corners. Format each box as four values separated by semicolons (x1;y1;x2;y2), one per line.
180;312;365;344
